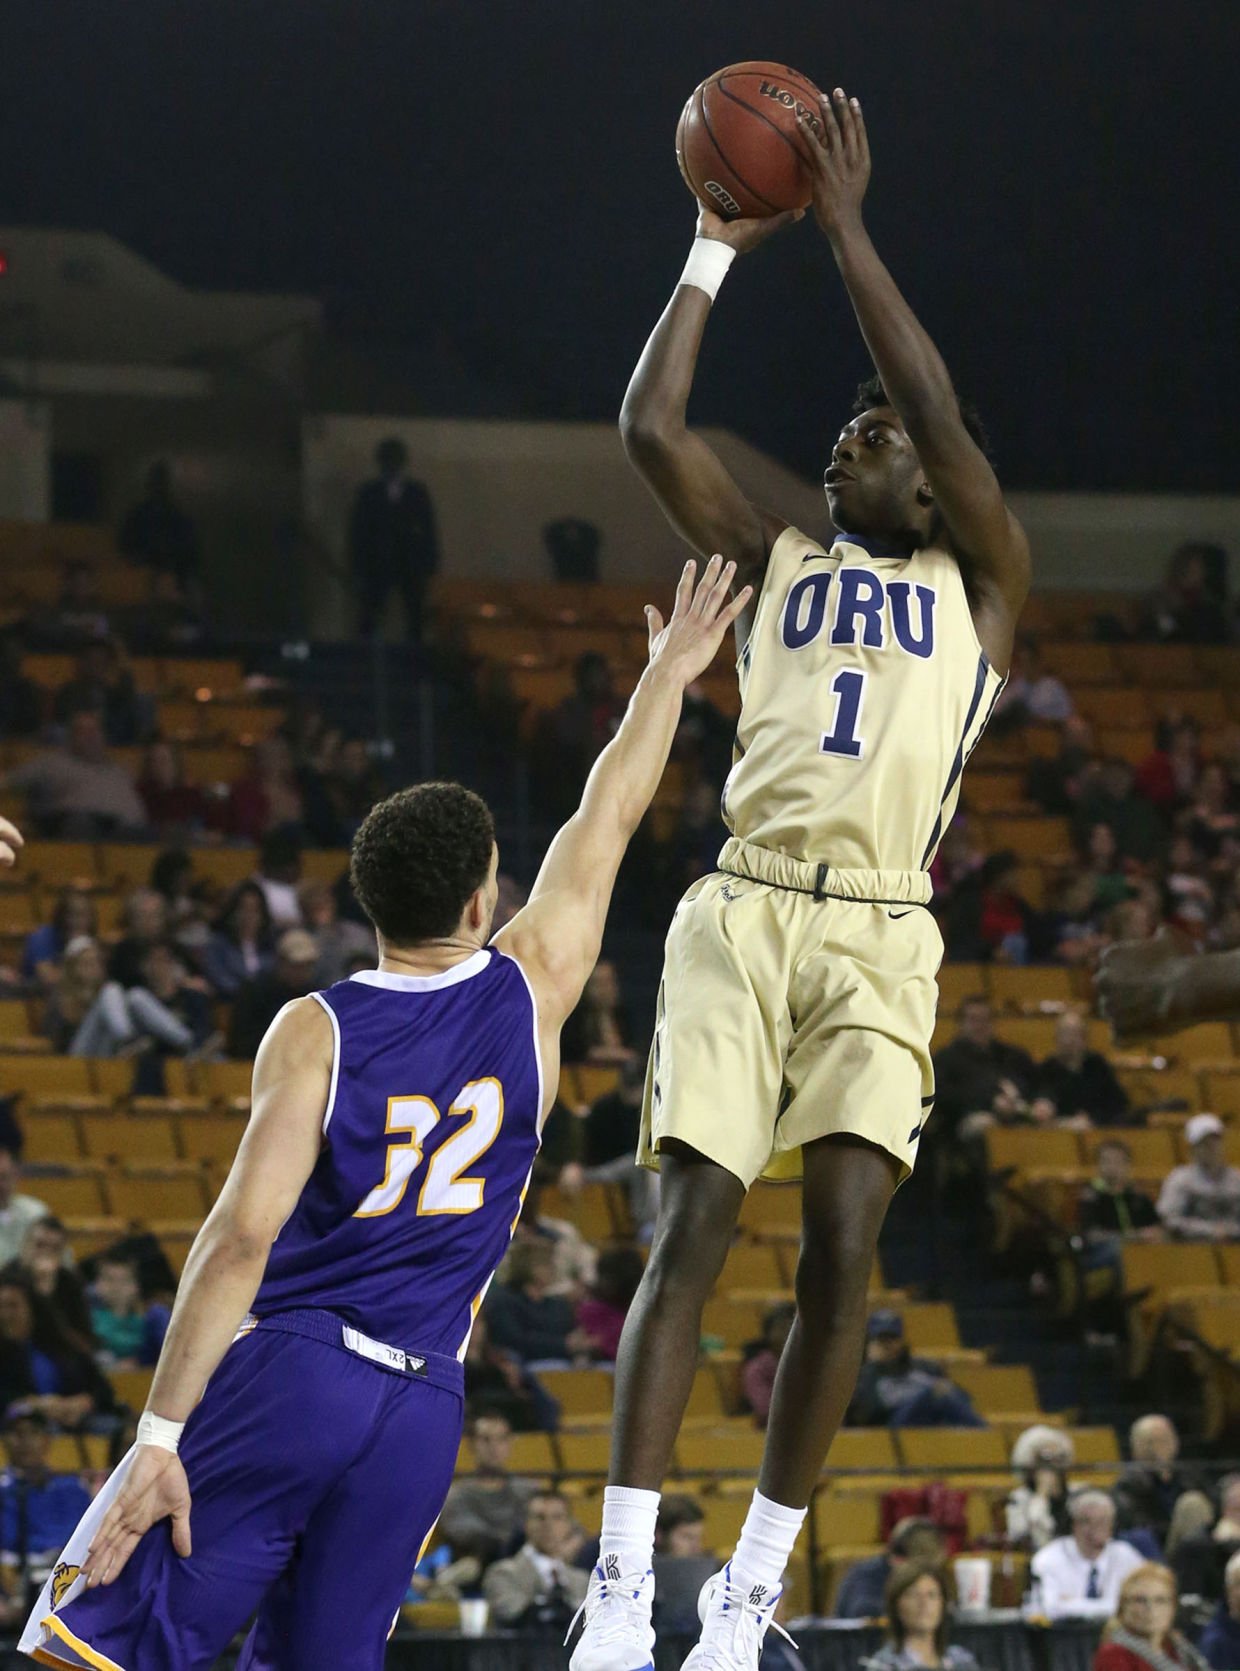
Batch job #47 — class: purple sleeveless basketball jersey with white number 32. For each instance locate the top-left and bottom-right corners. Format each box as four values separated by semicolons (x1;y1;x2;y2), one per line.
254;949;543;1355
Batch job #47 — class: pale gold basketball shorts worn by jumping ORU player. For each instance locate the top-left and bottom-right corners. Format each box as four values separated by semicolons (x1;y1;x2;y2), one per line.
637;839;943;1188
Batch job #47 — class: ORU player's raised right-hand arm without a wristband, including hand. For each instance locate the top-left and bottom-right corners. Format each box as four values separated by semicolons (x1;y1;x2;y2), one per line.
800;87;1029;672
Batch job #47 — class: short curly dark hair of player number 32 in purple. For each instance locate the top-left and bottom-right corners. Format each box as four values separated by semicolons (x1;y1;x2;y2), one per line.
349;784;495;946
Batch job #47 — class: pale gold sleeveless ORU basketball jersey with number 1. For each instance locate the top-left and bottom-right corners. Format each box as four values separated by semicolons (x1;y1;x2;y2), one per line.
724;528;1003;871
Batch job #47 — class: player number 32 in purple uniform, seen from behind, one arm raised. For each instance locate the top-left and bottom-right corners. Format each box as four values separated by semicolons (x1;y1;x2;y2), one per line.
20;558;747;1671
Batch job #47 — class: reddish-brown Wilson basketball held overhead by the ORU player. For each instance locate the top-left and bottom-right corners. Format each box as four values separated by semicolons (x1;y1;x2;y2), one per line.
675;60;822;221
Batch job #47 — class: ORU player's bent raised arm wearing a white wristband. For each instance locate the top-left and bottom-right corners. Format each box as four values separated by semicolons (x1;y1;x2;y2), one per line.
620;209;800;580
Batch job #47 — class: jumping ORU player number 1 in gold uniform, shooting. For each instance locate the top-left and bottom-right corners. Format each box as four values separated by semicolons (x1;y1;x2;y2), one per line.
572;90;1029;1671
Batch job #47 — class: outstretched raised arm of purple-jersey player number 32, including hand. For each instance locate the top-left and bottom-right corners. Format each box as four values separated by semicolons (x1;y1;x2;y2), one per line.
495;556;752;1033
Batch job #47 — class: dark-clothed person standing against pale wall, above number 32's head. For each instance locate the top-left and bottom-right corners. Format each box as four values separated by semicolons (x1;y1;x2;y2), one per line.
349;436;440;645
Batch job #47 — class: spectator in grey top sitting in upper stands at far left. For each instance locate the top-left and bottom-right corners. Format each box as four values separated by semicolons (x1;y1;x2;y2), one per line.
0;709;145;841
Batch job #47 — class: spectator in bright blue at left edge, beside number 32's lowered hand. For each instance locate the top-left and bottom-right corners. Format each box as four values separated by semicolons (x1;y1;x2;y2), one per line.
0;1410;90;1604
